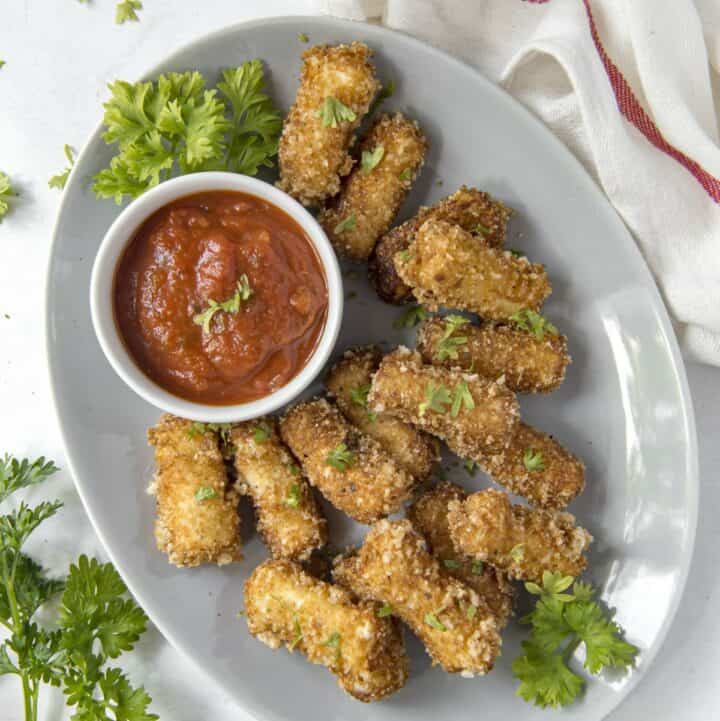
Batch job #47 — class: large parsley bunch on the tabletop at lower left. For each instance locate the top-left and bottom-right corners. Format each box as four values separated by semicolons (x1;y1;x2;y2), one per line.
0;456;157;721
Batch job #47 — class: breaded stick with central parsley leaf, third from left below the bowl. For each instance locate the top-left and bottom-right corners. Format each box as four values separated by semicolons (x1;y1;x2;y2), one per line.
280;398;416;523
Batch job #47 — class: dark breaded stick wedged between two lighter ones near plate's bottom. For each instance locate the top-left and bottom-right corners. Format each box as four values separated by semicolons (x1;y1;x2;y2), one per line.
407;481;515;627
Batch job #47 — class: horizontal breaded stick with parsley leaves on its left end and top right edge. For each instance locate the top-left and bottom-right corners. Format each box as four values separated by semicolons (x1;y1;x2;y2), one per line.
417;318;570;393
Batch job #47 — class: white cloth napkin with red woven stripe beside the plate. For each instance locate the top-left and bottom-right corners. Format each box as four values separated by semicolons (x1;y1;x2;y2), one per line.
326;0;720;365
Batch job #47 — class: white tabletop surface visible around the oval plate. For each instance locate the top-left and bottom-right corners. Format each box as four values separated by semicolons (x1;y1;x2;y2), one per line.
0;0;720;721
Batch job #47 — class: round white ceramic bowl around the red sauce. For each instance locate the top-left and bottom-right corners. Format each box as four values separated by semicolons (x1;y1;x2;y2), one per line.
90;172;343;423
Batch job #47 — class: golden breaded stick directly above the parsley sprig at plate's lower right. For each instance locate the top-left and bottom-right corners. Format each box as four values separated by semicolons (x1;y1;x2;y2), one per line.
448;489;592;584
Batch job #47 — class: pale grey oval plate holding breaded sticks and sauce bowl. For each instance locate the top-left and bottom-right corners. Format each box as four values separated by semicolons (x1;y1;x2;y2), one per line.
47;18;698;721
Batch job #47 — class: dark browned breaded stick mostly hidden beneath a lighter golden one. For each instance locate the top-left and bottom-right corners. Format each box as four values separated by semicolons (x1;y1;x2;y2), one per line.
368;185;512;304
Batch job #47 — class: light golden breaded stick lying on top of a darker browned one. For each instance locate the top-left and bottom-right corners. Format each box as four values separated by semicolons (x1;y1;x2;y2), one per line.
395;219;551;320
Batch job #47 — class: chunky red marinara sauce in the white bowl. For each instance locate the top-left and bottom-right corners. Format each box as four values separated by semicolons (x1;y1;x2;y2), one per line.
113;191;328;405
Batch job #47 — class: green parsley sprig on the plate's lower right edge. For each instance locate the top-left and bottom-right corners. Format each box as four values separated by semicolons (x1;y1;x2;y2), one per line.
512;571;638;708
